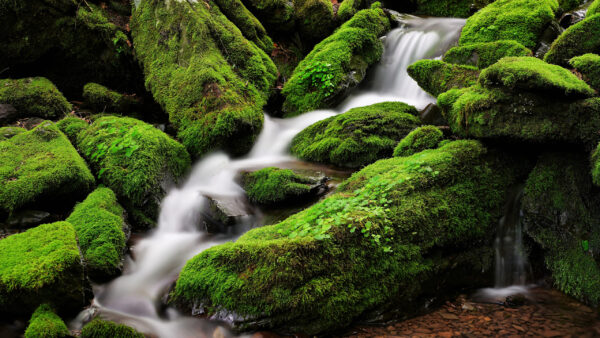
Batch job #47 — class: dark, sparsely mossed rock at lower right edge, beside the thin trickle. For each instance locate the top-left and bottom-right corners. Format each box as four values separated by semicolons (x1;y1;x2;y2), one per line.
522;153;600;306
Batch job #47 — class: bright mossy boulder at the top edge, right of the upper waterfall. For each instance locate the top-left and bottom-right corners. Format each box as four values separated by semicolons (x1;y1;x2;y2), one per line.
459;0;558;49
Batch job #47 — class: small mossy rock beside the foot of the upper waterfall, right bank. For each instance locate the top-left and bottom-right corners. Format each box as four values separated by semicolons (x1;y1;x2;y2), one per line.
407;60;479;96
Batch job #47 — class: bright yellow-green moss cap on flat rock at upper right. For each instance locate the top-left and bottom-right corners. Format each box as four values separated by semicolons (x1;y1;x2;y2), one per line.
479;57;594;98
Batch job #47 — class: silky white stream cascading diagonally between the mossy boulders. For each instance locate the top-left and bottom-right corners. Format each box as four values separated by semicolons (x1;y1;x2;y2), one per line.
72;16;464;337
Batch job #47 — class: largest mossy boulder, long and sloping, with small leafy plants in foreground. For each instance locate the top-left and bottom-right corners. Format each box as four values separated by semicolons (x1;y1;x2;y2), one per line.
171;141;528;334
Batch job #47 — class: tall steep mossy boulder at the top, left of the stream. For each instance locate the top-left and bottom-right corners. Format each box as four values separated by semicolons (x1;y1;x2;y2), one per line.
131;0;277;156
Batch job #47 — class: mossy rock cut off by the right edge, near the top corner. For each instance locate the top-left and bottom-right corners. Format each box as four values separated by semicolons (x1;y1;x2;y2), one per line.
544;14;600;67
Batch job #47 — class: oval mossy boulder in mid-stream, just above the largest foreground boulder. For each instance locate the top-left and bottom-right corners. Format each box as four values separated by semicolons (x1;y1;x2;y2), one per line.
291;102;420;168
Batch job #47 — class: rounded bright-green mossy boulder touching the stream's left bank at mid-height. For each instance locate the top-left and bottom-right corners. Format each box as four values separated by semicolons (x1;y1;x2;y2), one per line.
77;116;190;226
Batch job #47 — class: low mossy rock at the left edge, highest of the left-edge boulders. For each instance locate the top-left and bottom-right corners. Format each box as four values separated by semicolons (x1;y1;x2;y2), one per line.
0;77;72;123
